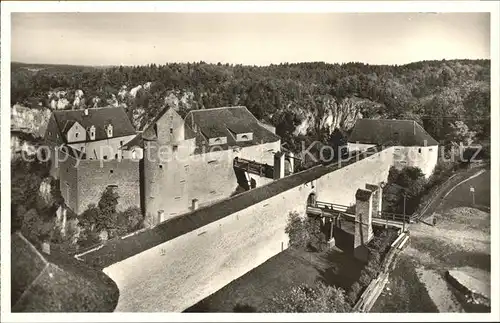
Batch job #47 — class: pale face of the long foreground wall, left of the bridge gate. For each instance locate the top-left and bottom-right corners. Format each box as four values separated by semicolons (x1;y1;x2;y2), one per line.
104;178;313;312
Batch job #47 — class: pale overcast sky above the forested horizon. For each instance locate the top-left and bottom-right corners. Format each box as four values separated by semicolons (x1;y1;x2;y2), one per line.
12;13;490;65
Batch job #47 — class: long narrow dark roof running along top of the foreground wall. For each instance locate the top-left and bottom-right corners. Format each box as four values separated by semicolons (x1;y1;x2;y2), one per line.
81;147;381;268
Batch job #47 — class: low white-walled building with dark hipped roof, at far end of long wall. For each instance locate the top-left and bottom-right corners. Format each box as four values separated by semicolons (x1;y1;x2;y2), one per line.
347;119;439;178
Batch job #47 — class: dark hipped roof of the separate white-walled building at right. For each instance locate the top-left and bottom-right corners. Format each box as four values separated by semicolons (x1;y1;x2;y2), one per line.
348;119;438;146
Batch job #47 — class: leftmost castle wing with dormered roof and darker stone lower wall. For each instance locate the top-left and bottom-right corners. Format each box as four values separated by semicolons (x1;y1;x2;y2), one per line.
45;107;140;214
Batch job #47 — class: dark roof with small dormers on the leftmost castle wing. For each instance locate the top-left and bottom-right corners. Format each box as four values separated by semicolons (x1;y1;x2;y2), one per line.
52;107;135;144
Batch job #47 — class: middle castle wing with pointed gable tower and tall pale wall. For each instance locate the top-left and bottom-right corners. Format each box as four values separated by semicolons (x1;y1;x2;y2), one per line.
142;106;281;225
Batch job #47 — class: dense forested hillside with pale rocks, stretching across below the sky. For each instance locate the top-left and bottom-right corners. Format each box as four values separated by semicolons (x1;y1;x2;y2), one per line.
11;60;490;149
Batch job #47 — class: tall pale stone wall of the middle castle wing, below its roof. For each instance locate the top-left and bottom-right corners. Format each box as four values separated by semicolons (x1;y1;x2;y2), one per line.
144;141;280;224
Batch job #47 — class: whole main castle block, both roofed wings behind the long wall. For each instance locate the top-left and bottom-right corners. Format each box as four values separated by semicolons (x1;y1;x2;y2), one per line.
45;106;282;226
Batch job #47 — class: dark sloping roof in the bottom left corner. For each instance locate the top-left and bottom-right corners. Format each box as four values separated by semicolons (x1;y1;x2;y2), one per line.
11;233;119;312
